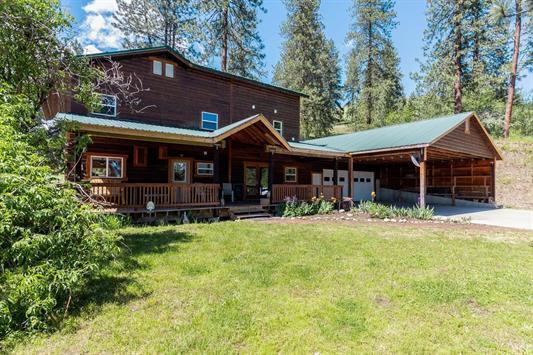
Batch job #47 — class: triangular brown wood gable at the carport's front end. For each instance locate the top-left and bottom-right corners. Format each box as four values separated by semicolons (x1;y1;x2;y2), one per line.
431;118;495;158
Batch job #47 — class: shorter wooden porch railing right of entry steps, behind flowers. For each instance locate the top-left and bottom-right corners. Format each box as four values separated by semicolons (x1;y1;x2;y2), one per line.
272;185;342;203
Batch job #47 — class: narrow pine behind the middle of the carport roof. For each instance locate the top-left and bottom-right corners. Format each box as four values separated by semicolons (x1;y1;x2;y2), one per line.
345;0;403;125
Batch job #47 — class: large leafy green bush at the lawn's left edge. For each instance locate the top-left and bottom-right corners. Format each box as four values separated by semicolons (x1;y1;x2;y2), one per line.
0;101;119;338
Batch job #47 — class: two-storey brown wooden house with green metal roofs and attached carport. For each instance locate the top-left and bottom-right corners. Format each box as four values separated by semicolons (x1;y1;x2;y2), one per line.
43;47;501;214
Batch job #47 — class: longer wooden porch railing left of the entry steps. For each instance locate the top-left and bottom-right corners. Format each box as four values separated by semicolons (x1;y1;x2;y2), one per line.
90;183;220;208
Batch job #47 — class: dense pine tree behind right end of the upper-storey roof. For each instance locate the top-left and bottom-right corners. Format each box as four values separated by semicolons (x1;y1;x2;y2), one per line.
273;0;341;138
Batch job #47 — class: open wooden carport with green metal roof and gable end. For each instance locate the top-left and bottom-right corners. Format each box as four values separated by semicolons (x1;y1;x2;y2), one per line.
305;112;501;206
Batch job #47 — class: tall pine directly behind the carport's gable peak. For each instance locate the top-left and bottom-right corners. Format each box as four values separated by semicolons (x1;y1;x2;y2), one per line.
413;0;509;119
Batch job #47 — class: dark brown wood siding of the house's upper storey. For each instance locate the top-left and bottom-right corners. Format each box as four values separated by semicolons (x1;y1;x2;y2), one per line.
64;56;300;140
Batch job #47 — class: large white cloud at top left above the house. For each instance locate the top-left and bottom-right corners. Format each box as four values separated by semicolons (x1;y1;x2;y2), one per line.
79;0;123;53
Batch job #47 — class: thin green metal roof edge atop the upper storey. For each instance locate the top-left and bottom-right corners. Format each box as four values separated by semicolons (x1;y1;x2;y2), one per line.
82;46;309;97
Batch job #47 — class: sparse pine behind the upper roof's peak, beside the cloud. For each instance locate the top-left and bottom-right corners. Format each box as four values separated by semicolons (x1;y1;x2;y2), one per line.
113;0;198;59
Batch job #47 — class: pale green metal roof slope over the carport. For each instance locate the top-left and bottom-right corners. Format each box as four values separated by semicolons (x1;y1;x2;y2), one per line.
302;112;472;153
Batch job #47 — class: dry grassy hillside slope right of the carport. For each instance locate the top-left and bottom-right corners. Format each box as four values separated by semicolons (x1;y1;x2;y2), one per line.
496;137;533;209
